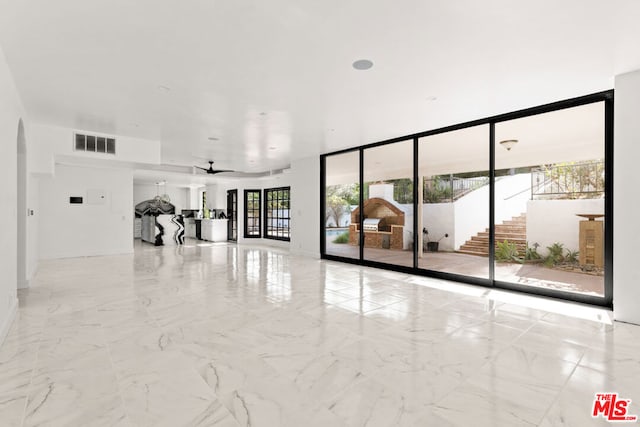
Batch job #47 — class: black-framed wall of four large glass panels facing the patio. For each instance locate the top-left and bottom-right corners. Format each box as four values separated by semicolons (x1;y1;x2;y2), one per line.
320;91;613;306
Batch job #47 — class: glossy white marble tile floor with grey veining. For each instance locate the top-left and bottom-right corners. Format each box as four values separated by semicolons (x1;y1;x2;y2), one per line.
0;241;640;427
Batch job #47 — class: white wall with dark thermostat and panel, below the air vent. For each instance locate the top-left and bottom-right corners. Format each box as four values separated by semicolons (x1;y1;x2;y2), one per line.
39;165;133;259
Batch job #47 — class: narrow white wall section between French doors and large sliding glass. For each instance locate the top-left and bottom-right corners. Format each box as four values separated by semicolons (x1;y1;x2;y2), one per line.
285;156;320;258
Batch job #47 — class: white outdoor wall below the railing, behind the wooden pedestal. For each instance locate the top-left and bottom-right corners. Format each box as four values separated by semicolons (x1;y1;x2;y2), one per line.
527;199;604;255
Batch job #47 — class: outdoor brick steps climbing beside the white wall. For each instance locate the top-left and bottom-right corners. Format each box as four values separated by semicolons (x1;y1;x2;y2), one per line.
457;213;527;256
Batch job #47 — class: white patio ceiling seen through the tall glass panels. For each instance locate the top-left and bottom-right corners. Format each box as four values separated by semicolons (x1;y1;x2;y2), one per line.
326;102;605;185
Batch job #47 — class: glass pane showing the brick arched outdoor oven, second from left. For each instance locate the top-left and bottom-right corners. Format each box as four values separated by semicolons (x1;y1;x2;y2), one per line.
356;140;414;267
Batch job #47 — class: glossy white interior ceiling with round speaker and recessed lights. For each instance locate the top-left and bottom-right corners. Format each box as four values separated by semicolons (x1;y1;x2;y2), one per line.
0;0;640;181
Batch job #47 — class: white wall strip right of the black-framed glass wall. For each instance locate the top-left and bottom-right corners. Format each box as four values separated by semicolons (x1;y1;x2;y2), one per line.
613;70;640;324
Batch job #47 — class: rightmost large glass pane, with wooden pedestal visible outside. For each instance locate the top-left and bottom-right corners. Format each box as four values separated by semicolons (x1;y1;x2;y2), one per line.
495;102;605;296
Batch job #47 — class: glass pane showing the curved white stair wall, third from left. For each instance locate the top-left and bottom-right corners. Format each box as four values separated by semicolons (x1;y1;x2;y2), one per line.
418;125;489;279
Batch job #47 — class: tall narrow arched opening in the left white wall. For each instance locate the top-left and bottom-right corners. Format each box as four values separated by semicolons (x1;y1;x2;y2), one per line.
16;119;29;288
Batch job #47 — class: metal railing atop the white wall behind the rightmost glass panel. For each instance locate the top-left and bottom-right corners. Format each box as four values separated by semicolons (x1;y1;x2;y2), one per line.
531;162;604;199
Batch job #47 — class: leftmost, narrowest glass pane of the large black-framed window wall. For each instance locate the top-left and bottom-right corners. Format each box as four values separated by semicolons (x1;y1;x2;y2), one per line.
324;151;360;258
